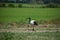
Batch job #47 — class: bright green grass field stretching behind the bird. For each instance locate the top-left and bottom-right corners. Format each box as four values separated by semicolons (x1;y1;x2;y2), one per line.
0;8;60;22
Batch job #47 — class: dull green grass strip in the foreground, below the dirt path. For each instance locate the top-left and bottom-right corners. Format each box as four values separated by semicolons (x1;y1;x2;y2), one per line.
0;32;60;40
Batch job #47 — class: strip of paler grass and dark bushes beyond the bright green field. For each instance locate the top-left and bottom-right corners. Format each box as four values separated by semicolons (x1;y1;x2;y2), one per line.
0;3;60;8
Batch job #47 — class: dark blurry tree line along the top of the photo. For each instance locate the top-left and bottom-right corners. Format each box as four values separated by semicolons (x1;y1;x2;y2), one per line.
0;0;60;4
